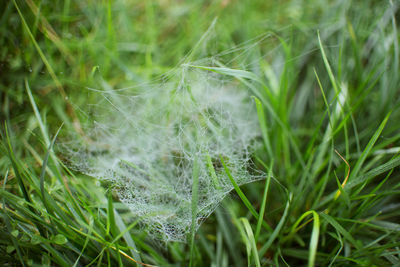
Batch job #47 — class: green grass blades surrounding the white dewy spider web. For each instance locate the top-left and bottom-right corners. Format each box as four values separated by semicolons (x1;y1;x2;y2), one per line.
0;0;400;266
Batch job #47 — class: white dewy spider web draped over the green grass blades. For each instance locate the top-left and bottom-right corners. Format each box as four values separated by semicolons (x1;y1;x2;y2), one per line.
64;30;280;241
